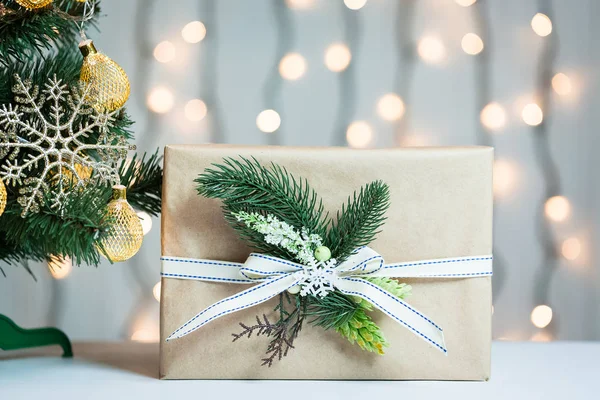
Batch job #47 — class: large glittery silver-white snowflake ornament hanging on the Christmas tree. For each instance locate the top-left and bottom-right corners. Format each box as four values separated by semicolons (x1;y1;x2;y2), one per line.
0;76;133;216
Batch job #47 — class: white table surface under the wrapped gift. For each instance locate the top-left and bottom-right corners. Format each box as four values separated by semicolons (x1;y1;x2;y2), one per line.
0;342;600;400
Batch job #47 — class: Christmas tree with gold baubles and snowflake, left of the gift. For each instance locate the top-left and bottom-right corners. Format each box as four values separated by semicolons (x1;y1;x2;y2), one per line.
0;0;162;354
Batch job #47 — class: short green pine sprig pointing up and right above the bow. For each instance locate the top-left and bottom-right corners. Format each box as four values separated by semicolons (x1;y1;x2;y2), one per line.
326;181;390;261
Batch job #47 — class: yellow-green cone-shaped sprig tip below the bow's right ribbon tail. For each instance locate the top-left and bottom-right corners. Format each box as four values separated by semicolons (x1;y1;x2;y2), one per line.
336;308;389;354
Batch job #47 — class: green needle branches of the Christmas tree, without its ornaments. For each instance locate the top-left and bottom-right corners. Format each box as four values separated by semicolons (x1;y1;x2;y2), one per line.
0;0;162;273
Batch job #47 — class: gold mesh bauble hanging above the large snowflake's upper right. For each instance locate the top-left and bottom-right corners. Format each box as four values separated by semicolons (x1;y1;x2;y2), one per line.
79;40;130;112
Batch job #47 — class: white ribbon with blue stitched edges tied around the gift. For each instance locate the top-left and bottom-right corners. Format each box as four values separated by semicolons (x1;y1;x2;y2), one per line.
161;247;492;353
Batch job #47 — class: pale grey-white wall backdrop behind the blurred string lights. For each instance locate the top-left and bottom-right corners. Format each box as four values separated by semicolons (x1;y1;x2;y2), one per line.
0;0;600;340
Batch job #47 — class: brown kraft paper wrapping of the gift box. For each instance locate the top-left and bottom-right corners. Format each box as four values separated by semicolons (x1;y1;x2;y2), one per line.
160;145;493;380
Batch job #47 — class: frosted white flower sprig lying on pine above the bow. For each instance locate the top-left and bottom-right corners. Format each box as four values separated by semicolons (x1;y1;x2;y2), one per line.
233;211;323;265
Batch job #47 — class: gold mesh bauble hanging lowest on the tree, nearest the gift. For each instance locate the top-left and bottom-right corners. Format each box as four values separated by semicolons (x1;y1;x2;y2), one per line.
100;185;144;262
